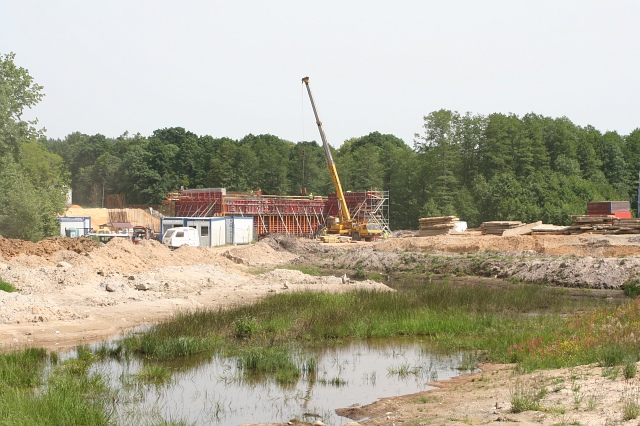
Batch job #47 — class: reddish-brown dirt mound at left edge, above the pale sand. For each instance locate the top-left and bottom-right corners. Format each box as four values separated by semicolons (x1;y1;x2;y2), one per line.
0;237;101;259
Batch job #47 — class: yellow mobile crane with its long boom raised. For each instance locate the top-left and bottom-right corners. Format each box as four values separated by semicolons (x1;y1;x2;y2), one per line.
302;77;382;241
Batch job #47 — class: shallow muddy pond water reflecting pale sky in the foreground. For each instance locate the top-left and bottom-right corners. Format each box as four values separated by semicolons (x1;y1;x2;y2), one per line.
96;338;476;425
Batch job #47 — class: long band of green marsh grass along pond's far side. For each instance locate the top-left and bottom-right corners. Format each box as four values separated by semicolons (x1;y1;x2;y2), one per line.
125;281;624;370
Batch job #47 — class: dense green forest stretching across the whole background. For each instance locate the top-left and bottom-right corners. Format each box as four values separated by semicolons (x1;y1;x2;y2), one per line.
0;55;640;239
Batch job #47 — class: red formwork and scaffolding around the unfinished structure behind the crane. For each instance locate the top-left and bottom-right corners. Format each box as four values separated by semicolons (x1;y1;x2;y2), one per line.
164;188;391;238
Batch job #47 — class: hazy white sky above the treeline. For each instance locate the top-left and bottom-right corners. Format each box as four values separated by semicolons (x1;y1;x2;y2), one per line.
0;0;640;147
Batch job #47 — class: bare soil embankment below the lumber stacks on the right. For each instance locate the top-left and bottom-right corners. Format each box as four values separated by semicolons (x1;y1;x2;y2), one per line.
288;232;640;289
